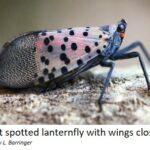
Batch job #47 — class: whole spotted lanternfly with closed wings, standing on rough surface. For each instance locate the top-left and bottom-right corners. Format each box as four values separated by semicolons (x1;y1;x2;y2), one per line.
0;19;150;110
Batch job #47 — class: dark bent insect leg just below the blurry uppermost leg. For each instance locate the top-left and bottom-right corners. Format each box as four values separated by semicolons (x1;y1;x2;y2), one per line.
110;50;150;90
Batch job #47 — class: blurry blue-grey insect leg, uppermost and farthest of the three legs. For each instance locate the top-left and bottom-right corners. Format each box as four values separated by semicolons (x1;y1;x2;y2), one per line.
115;41;150;63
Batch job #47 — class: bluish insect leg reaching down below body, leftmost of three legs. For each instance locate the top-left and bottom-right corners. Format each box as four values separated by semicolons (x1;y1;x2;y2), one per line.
98;61;115;111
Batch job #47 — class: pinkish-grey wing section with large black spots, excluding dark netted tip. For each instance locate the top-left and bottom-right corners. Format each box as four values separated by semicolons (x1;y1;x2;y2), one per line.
35;27;109;84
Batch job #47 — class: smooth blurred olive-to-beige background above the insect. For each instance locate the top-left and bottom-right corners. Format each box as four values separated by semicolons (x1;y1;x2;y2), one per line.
0;0;150;67
